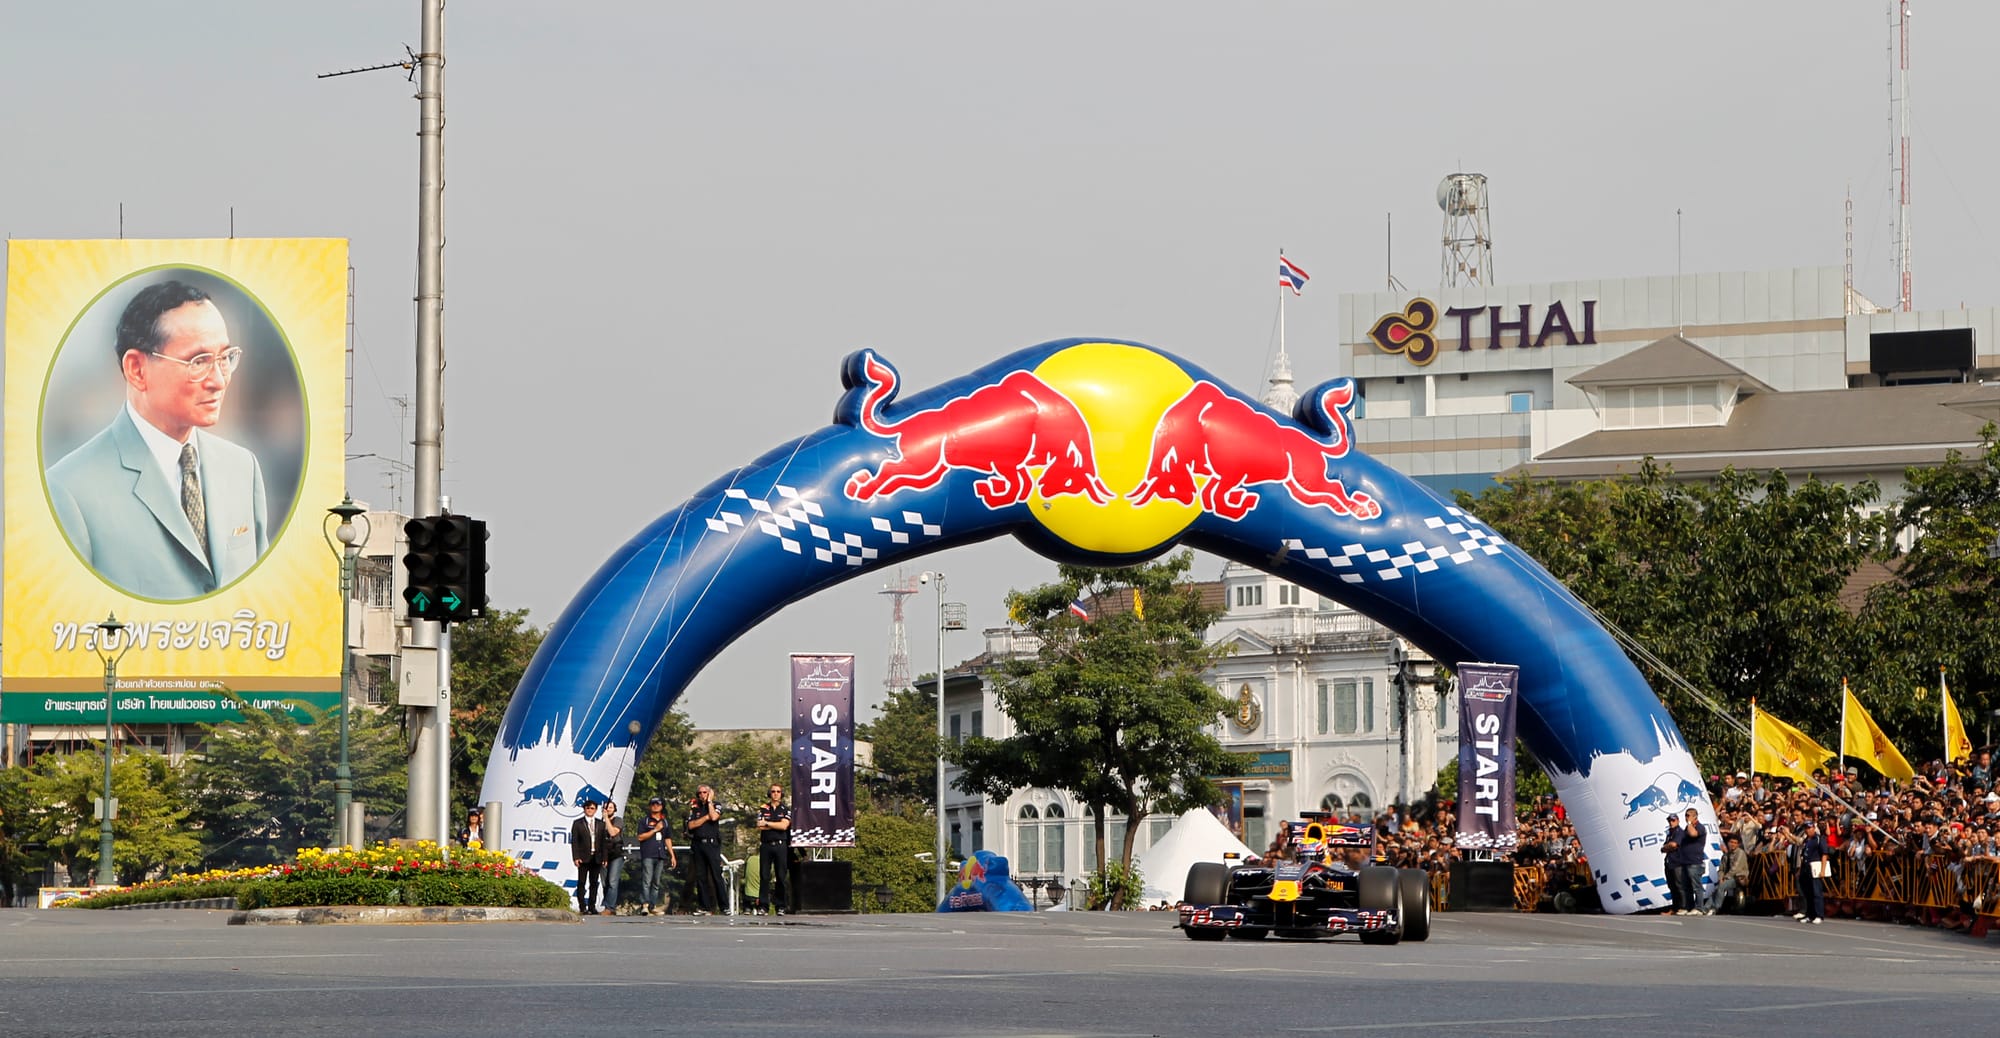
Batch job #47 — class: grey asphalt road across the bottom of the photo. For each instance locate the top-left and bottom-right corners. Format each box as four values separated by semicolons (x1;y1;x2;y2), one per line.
0;910;2000;1038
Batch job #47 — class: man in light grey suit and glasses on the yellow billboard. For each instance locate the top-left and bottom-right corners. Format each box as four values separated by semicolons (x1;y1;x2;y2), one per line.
48;280;270;600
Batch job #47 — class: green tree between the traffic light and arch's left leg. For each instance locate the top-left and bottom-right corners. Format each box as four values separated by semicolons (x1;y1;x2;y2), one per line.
452;610;544;824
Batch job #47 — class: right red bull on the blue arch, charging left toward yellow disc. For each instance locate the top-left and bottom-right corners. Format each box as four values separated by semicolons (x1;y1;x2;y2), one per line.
1132;380;1382;520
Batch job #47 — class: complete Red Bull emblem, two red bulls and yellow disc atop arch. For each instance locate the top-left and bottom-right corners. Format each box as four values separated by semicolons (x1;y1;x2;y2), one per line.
846;342;1382;554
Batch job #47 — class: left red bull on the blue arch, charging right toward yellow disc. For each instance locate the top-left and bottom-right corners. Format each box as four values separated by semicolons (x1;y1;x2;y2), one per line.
846;354;1112;508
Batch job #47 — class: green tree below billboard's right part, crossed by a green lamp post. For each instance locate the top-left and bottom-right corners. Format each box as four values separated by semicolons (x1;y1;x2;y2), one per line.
188;698;408;866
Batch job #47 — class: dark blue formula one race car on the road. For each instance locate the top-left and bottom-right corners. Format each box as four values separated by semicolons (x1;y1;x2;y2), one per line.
1180;814;1430;944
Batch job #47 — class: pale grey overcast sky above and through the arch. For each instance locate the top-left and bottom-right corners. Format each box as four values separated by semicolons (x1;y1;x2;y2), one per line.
0;0;2000;726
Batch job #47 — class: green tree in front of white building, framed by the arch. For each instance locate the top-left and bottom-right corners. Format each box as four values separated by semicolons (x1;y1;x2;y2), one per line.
948;552;1244;908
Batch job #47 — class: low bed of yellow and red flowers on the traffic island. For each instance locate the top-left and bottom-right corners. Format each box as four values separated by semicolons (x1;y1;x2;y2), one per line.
68;842;570;908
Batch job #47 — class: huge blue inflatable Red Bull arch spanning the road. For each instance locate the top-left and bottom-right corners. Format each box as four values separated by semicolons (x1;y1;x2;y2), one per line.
480;340;1720;914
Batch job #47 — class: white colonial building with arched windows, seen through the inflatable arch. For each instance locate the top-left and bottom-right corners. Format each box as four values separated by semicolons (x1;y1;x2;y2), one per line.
944;564;1458;900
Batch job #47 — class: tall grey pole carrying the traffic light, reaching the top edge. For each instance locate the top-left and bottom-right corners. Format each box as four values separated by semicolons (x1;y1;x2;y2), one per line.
406;0;452;846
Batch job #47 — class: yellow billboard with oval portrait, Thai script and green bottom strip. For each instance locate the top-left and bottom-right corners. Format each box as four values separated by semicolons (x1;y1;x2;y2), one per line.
0;238;348;724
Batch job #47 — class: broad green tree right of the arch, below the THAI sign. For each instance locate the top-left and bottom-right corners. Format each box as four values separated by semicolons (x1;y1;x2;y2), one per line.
1460;458;1882;770
